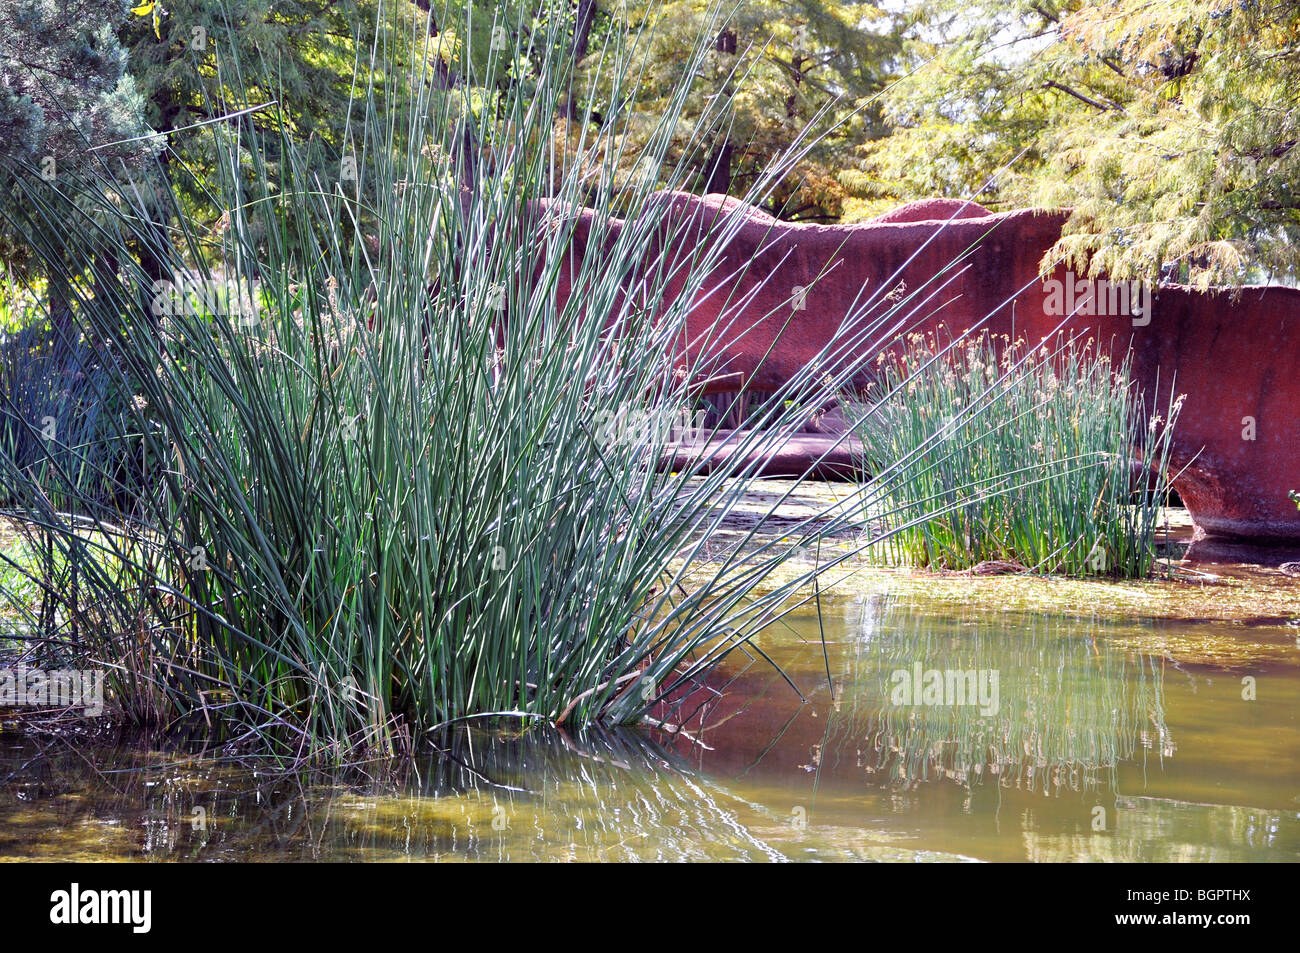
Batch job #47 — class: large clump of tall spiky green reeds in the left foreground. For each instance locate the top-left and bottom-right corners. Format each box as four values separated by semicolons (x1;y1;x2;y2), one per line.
0;4;935;757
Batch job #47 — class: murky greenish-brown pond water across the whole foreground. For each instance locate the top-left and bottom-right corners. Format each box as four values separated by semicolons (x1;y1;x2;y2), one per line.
0;595;1300;861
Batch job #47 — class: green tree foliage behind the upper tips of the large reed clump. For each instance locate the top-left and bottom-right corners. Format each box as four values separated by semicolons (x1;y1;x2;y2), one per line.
115;0;618;252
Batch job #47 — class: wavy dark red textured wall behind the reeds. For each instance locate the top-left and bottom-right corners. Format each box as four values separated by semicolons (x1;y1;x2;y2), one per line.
530;192;1300;540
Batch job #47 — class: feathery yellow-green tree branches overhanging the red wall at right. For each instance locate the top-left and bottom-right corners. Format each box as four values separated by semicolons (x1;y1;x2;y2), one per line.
861;0;1300;286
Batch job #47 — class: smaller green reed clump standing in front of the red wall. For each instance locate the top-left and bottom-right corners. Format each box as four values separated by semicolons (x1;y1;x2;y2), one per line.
858;334;1178;576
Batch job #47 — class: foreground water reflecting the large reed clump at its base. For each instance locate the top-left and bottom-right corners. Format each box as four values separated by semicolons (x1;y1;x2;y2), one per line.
0;731;781;861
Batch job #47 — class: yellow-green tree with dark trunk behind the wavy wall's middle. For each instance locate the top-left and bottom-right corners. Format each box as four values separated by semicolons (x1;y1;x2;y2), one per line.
579;0;900;221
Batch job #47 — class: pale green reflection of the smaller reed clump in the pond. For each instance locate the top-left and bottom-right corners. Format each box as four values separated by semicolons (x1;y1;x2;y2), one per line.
833;597;1174;790
